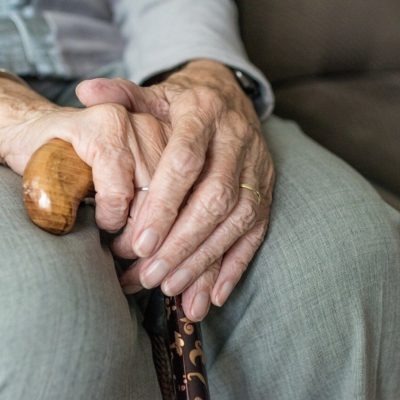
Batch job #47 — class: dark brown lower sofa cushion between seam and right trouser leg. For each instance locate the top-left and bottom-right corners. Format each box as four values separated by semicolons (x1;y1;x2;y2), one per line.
275;72;400;197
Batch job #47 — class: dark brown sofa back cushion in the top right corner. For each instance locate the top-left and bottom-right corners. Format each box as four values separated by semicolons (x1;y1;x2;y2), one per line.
237;0;400;81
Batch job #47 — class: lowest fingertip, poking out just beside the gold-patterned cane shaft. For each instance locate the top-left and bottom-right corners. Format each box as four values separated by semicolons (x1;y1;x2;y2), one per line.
182;261;221;322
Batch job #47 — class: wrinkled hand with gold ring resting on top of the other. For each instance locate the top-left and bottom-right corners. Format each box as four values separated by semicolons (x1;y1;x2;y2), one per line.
77;60;274;320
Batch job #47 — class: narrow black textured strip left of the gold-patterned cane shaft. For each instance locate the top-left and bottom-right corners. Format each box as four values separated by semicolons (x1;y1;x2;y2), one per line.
150;335;176;400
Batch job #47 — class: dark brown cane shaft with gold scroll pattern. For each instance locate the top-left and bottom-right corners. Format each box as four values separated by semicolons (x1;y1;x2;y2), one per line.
165;296;210;400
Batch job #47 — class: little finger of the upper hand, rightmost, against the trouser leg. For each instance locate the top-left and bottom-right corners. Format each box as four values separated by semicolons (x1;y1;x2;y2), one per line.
211;221;267;307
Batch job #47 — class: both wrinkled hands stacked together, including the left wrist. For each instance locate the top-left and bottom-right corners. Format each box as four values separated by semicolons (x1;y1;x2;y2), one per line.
0;61;274;320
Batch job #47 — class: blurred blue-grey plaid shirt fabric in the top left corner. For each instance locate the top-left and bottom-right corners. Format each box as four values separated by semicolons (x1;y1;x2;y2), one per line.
0;0;122;78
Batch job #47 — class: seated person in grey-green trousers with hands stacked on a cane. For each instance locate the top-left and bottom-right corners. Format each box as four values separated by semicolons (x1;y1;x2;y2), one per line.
0;0;400;400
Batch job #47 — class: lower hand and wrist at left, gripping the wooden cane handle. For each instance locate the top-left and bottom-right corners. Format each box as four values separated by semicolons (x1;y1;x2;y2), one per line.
0;79;166;232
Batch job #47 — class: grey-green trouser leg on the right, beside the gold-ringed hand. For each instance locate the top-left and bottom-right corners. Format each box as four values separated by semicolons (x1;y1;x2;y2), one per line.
204;117;400;400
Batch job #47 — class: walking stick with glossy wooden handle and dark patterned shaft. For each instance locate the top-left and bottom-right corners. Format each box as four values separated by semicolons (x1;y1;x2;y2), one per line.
23;139;209;400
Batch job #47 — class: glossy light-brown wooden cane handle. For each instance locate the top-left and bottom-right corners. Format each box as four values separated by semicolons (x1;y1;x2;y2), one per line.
23;139;93;235
